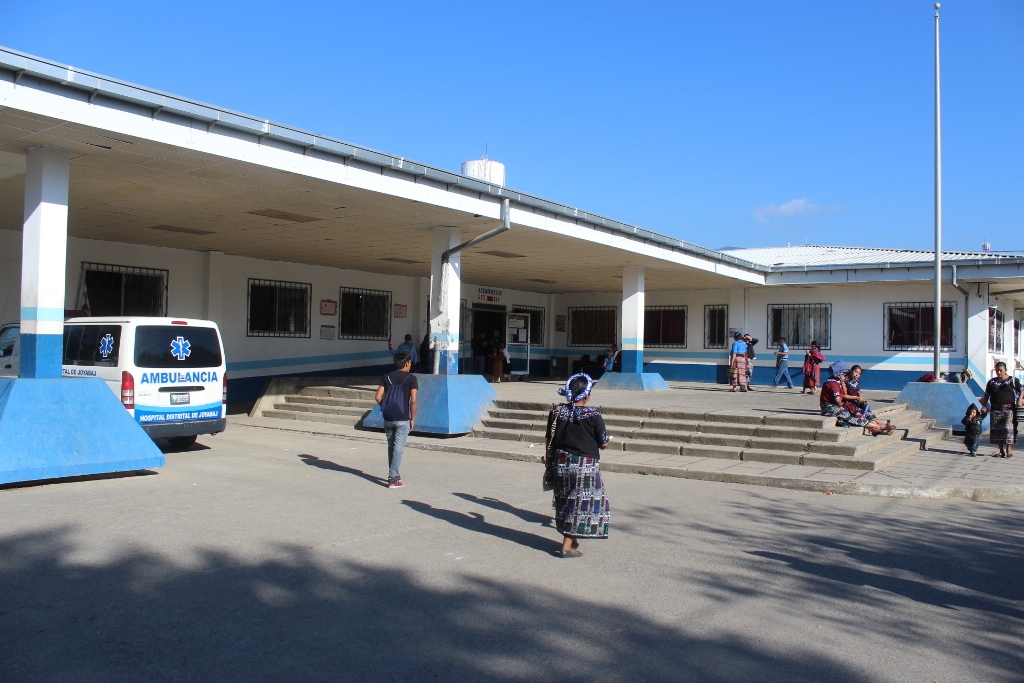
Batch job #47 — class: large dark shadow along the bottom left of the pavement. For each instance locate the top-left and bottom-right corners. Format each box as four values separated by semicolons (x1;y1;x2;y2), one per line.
0;527;868;683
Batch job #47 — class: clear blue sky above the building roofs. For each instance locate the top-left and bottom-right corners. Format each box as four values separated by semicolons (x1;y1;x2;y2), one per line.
0;0;1024;251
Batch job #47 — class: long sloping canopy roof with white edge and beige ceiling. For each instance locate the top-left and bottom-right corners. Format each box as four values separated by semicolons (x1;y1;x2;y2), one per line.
0;48;768;292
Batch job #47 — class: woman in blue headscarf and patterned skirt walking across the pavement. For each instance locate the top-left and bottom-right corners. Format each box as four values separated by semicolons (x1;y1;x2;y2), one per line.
545;373;611;557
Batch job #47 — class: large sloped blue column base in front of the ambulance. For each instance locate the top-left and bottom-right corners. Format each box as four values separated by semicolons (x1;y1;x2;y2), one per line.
0;378;164;483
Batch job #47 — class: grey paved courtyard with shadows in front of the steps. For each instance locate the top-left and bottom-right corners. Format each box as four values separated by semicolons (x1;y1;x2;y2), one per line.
0;427;1024;682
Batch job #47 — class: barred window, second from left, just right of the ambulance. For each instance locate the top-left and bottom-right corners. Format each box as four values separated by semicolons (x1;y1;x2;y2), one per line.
246;278;313;337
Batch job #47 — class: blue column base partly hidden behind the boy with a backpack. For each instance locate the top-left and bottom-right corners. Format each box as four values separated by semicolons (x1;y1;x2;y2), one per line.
362;375;498;434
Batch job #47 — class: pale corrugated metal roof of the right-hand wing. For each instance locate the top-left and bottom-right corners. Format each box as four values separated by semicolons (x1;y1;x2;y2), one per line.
722;245;1024;269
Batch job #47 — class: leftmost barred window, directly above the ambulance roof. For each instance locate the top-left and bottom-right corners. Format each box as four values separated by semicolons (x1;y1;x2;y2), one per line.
79;263;169;317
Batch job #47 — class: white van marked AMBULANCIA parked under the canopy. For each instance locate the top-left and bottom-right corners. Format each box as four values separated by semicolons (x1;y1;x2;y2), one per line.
62;317;227;449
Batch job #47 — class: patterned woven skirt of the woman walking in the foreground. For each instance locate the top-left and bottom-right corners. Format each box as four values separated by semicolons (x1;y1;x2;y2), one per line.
552;450;611;539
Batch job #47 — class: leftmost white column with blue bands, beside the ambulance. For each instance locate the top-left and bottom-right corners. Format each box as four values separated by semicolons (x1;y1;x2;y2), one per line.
22;146;71;378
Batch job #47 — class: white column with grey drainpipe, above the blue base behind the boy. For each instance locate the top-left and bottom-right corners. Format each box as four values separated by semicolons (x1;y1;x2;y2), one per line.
430;227;462;375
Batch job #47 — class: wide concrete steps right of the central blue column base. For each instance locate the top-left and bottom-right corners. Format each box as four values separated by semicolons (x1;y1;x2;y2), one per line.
473;400;945;470
